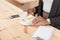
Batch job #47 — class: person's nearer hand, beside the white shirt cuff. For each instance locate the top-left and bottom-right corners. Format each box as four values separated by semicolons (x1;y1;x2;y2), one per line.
32;16;49;25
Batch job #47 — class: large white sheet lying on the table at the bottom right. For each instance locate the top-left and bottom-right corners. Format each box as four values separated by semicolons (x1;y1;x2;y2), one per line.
32;26;54;40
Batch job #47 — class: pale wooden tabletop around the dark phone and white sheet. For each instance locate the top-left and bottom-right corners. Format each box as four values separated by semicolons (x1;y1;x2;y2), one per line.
0;0;60;40
